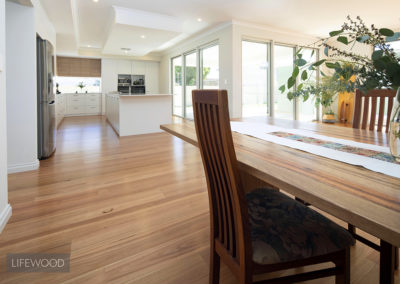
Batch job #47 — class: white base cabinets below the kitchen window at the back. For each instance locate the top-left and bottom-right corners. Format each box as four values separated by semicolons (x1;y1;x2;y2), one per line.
65;93;101;116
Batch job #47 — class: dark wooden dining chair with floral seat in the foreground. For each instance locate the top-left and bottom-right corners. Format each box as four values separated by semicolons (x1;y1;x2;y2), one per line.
193;90;354;284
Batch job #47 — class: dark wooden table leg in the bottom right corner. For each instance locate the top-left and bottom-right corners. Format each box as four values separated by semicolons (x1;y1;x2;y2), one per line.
379;240;397;284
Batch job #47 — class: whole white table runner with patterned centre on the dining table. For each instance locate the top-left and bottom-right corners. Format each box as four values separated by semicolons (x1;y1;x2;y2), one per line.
231;121;400;178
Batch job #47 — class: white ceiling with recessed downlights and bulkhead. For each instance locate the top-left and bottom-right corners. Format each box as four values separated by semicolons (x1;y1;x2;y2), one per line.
40;0;400;56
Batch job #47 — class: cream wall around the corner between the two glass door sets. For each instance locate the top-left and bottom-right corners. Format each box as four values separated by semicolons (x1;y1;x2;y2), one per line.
160;21;316;118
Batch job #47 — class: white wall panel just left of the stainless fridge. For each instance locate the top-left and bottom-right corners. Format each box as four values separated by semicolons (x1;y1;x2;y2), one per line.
6;2;39;173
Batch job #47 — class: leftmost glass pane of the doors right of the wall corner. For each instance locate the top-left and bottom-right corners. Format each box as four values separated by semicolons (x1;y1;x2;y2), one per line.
242;41;268;117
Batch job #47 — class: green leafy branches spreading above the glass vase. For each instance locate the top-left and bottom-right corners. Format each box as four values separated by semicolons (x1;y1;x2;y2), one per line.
279;16;400;106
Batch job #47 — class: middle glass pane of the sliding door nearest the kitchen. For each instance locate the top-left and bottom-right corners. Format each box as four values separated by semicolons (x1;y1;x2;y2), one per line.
185;52;197;118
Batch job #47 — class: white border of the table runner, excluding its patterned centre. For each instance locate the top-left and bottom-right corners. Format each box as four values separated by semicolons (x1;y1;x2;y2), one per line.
231;121;400;178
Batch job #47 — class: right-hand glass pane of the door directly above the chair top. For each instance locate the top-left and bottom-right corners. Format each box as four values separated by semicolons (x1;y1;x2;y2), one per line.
202;45;219;89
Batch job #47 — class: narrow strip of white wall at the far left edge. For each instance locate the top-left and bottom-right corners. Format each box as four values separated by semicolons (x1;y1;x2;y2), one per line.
0;0;11;233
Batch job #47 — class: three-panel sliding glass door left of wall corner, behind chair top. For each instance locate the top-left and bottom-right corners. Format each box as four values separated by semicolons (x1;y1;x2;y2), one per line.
171;44;219;119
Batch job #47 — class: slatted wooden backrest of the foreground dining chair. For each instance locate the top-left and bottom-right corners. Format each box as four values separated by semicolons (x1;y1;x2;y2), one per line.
192;90;251;261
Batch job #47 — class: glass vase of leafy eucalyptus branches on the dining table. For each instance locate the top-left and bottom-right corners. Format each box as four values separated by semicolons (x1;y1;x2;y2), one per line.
280;16;400;160
